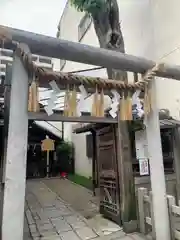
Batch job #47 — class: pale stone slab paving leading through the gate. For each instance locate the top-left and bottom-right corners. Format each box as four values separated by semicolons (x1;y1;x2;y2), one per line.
24;180;146;240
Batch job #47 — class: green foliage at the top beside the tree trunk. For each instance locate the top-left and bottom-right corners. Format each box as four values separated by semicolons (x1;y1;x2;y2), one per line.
71;0;108;14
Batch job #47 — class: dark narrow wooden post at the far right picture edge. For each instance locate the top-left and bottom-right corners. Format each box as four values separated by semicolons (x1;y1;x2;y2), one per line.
173;128;180;202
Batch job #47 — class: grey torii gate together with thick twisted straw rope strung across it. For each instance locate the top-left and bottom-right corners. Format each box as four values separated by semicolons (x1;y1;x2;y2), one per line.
0;24;180;240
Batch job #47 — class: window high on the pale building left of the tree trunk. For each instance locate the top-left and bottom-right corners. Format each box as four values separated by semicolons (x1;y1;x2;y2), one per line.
78;14;92;42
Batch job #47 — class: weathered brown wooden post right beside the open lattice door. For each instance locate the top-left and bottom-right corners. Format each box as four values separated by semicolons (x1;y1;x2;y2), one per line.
117;121;137;232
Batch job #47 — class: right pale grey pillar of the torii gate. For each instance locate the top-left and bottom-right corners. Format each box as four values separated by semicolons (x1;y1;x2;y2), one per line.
146;79;170;240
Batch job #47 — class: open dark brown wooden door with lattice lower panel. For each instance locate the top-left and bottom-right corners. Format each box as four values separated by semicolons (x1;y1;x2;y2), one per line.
96;125;121;224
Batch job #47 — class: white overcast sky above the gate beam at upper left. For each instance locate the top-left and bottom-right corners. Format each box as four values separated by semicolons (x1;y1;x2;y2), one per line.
0;0;66;37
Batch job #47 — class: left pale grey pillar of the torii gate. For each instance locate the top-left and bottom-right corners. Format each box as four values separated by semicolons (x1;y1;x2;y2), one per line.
2;45;28;240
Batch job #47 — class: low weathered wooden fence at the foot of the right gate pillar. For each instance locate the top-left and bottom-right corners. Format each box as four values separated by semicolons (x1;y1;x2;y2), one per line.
138;188;180;240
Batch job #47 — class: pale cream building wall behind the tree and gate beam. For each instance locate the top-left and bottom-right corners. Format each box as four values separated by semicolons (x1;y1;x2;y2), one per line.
59;0;180;176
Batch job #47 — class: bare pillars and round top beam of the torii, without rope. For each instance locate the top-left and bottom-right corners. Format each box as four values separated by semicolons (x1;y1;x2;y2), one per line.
0;26;177;240
